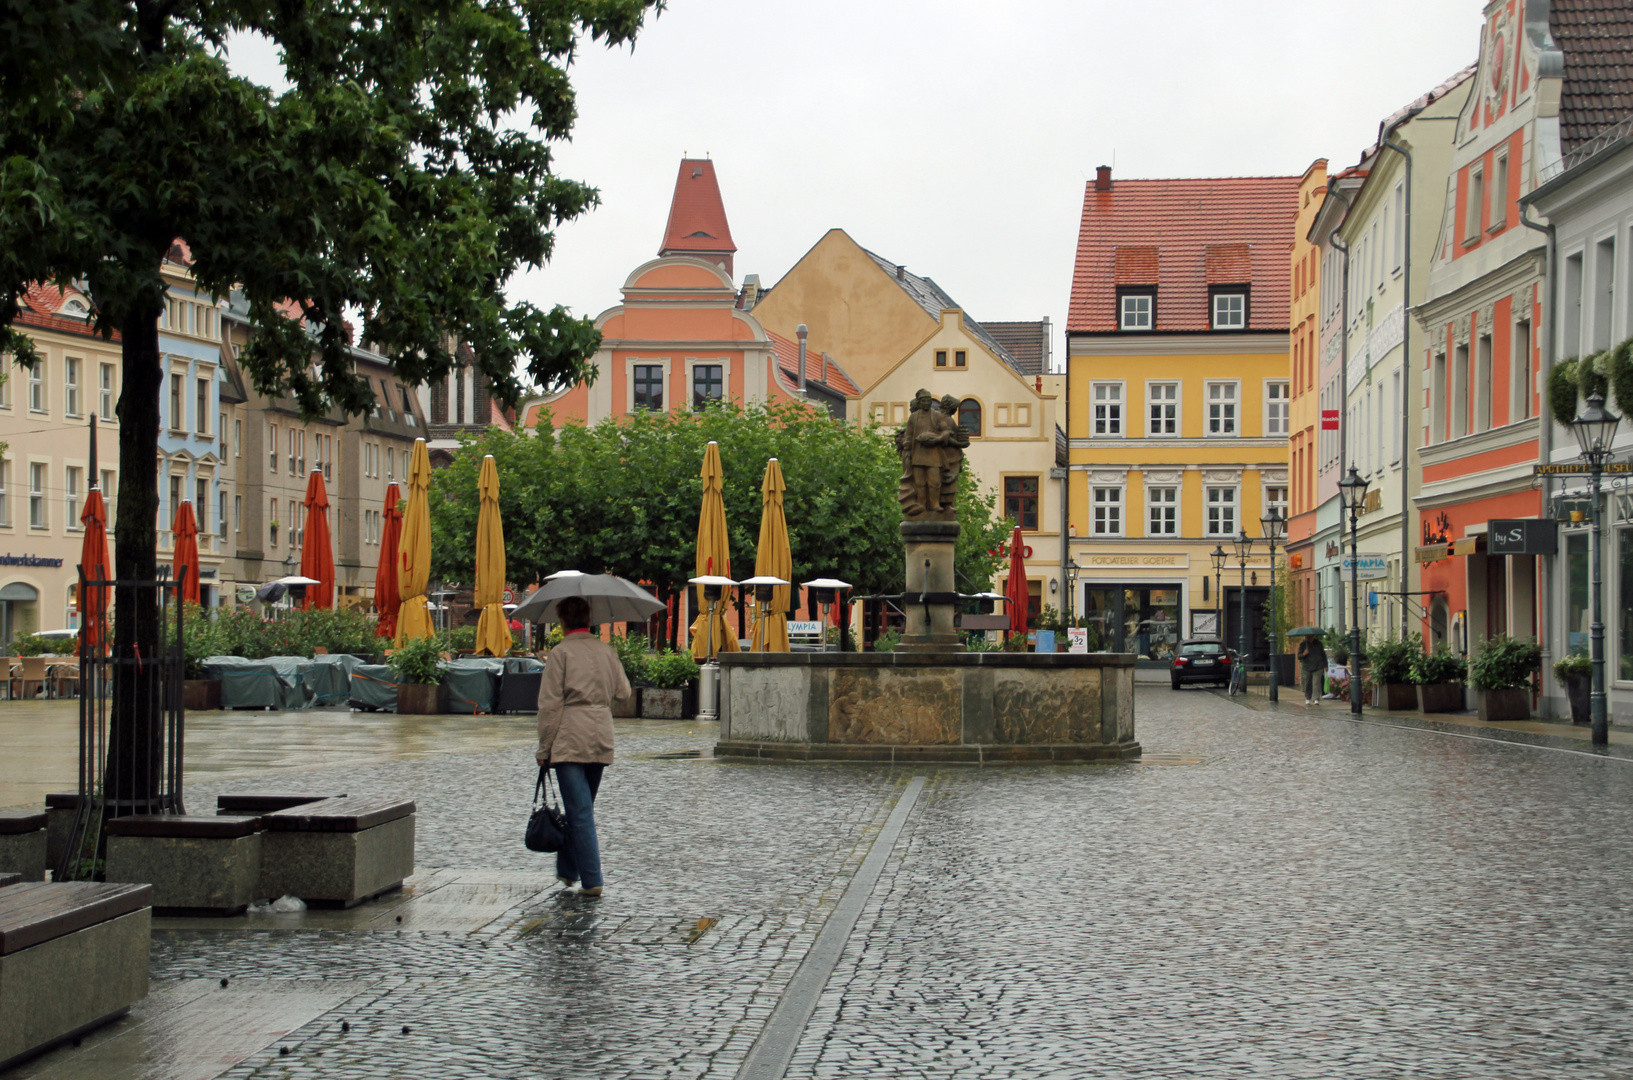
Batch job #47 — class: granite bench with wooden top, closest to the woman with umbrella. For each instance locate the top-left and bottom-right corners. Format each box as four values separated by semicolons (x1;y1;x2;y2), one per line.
261;797;415;907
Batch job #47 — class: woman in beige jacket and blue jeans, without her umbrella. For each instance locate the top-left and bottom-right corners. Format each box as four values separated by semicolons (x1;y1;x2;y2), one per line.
536;596;634;897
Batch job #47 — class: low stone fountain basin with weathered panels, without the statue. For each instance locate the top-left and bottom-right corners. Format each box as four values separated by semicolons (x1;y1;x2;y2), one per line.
715;652;1140;765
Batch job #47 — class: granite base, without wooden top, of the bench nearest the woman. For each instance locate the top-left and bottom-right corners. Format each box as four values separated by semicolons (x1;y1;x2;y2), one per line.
256;814;416;907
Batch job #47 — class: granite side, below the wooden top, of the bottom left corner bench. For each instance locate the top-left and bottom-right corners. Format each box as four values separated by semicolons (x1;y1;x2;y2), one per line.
0;907;154;1069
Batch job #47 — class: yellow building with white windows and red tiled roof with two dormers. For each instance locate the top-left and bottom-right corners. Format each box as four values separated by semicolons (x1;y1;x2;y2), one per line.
1066;167;1300;663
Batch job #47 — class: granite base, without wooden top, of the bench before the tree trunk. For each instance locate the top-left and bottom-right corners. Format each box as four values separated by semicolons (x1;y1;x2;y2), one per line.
106;833;264;915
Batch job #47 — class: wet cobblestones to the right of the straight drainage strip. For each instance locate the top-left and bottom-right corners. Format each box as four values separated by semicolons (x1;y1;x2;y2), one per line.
789;688;1633;1078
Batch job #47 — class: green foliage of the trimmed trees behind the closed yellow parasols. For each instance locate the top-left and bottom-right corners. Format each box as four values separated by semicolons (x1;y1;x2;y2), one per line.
431;402;1006;595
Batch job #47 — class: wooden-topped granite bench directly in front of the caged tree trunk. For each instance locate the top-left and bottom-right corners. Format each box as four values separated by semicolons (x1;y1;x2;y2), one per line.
103;814;263;915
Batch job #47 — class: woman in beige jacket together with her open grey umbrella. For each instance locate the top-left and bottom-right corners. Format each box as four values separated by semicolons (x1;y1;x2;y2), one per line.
516;573;663;899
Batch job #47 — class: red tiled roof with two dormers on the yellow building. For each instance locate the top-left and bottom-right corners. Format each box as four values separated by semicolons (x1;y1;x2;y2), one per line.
1066;176;1298;333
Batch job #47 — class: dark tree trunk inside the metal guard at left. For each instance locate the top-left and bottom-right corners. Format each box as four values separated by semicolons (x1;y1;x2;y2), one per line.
106;309;165;815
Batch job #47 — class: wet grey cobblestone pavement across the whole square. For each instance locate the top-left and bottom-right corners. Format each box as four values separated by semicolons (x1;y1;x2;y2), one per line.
16;686;1633;1078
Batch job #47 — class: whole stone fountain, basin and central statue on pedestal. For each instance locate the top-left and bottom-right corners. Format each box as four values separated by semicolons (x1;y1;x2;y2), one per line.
715;390;1140;765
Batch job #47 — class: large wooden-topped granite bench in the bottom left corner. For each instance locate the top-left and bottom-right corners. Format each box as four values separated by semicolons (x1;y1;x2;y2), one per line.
0;881;154;1069
